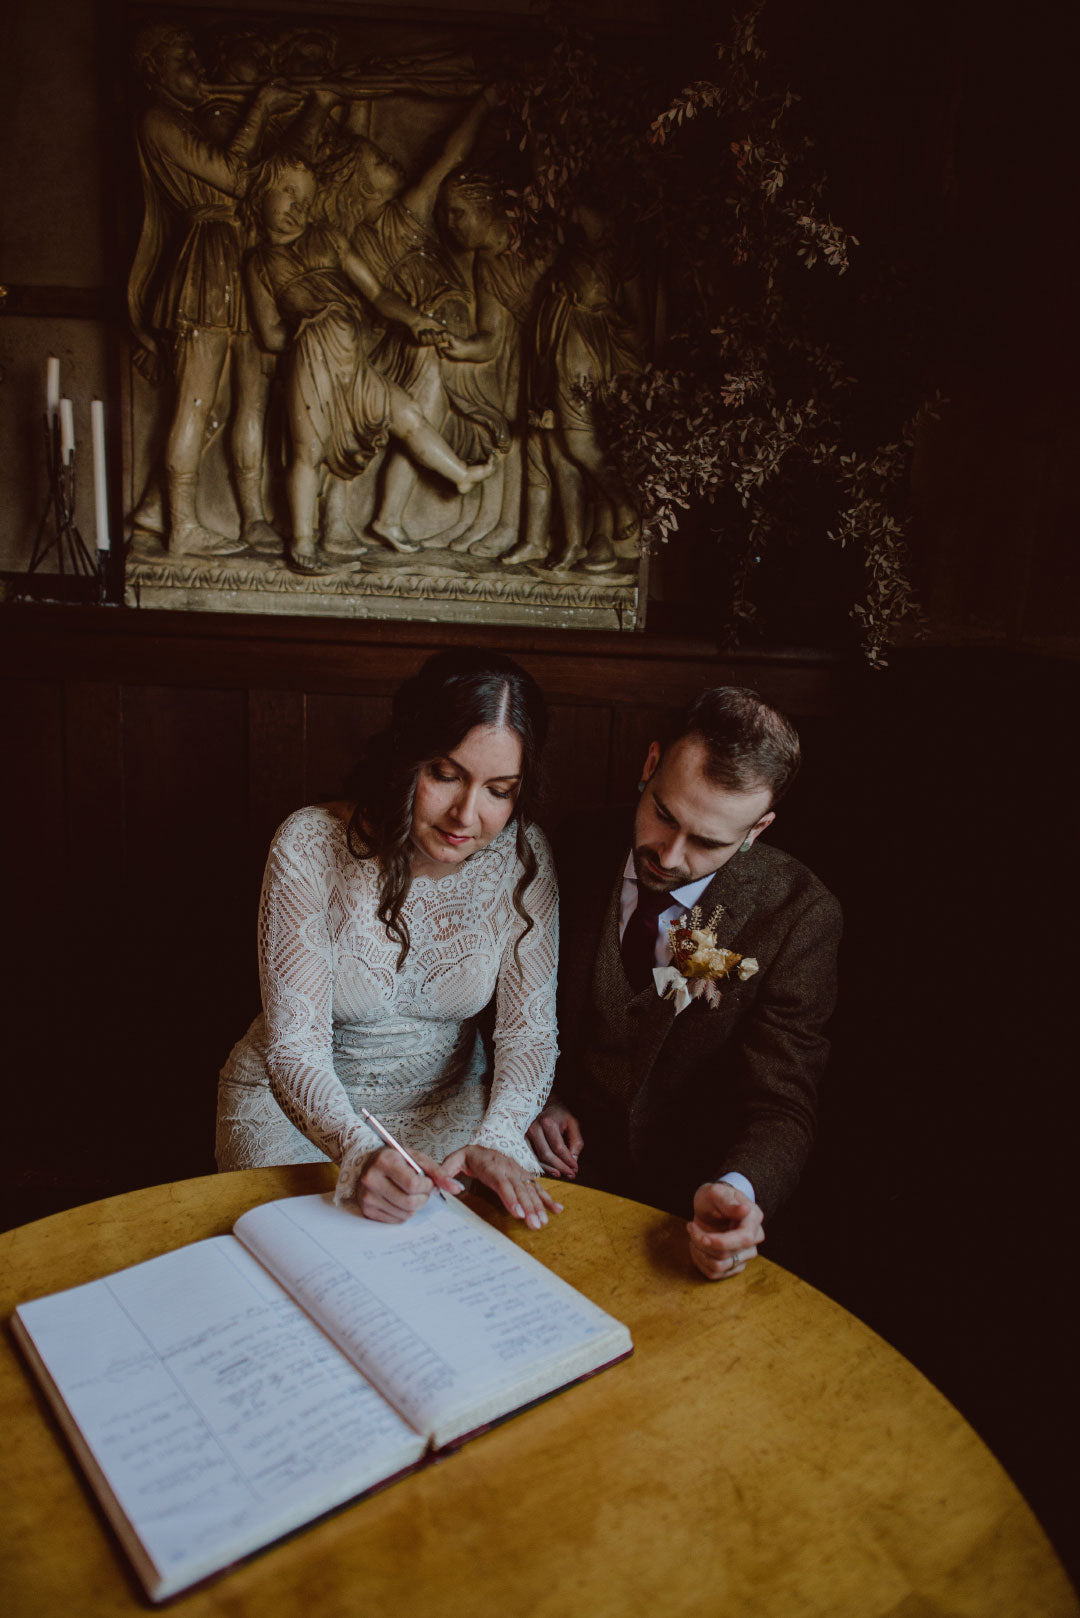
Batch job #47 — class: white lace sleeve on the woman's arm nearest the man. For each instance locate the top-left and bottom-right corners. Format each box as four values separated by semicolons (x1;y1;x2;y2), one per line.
476;827;559;1173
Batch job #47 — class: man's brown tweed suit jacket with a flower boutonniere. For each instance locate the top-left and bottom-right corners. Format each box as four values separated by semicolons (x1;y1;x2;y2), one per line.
555;809;840;1215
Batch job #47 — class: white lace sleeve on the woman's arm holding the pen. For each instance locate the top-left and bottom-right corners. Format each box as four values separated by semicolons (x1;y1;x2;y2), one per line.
259;809;381;1201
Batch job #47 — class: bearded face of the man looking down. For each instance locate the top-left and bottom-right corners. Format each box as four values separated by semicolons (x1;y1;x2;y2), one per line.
633;736;776;893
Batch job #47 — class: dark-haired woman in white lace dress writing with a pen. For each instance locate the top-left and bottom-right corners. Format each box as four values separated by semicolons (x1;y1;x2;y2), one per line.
217;650;559;1230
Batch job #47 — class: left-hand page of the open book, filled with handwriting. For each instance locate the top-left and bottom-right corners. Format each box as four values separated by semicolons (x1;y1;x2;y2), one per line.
18;1236;424;1597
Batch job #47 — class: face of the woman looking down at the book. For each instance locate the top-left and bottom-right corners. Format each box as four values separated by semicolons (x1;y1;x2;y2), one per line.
413;725;521;875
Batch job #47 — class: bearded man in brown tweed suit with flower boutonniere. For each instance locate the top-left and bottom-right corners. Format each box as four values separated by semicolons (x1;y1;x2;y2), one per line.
529;686;840;1280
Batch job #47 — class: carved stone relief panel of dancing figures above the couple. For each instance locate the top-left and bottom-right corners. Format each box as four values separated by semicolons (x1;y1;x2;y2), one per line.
126;11;651;628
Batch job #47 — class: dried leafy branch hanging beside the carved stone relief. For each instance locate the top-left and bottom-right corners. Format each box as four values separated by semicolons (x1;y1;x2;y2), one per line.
507;0;929;667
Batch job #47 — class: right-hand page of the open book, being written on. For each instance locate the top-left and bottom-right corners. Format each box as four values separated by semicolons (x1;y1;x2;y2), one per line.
235;1196;631;1443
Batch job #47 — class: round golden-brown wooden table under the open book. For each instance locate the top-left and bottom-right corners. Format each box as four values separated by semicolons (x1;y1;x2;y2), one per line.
0;1167;1080;1618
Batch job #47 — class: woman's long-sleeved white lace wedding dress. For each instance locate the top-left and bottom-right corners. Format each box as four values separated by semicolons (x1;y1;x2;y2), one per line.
217;807;559;1197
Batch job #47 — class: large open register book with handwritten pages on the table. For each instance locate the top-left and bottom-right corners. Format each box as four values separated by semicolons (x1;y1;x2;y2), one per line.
13;1196;631;1600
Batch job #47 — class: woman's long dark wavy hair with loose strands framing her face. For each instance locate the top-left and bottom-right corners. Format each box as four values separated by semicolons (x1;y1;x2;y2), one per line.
348;647;547;971
